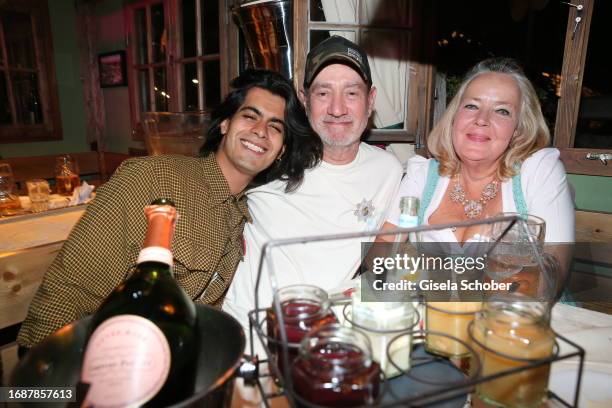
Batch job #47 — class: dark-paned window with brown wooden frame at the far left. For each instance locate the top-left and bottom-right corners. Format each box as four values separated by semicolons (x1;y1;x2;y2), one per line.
0;0;61;143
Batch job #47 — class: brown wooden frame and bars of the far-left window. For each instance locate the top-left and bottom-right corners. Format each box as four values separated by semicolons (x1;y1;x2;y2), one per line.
0;0;63;143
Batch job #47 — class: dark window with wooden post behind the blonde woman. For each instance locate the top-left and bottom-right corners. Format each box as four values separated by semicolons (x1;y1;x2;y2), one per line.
435;0;612;176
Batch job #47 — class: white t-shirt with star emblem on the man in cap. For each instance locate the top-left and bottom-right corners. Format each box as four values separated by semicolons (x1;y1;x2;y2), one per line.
223;143;402;328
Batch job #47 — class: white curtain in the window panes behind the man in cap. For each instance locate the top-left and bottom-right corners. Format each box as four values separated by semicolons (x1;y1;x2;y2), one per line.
321;0;409;128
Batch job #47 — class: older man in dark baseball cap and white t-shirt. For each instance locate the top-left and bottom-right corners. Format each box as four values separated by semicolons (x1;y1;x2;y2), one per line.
223;36;402;340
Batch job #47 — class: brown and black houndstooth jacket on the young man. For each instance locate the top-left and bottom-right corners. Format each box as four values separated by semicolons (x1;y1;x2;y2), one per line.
17;154;250;347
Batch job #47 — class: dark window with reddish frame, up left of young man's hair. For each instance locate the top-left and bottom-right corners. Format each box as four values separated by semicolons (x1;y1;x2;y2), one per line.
125;0;225;139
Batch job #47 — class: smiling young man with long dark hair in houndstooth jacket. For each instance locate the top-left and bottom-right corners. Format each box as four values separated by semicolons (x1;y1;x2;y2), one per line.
18;70;322;347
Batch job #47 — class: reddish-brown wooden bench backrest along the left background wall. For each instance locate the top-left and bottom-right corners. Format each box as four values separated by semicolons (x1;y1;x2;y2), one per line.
2;152;130;193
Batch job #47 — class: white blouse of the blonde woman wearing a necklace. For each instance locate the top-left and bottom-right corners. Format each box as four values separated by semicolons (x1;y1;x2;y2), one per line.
387;148;575;242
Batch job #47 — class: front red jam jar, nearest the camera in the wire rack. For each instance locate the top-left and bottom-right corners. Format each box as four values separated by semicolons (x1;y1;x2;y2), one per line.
291;324;381;407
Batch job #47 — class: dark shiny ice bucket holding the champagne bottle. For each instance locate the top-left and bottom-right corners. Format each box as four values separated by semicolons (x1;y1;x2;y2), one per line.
9;305;246;407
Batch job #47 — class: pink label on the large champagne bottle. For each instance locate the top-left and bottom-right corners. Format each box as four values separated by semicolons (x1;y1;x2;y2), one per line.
81;315;170;407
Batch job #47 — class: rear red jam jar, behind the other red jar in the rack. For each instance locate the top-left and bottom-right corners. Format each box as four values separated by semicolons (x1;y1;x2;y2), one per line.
266;285;338;375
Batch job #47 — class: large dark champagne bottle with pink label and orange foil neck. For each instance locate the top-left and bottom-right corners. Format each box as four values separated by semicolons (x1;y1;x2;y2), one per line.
81;199;198;407
